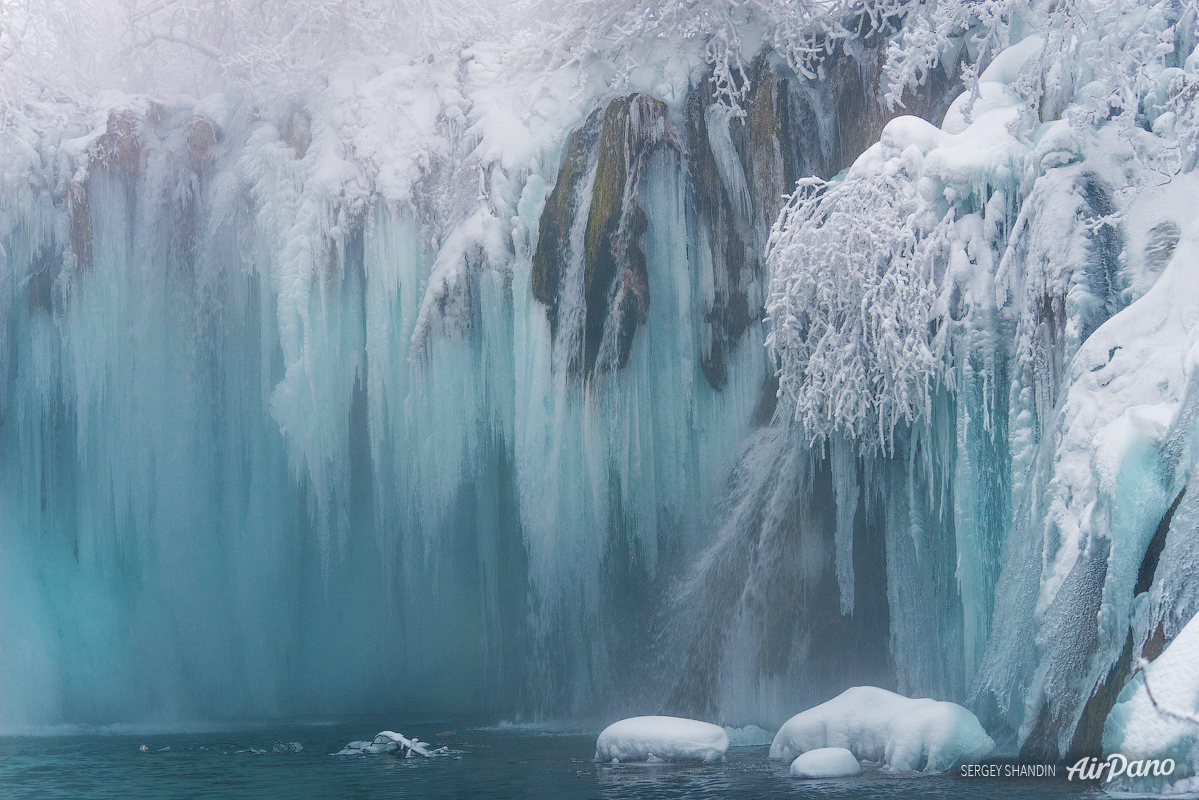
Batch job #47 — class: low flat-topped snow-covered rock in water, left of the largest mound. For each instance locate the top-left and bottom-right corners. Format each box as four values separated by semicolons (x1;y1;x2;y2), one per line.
596;716;729;762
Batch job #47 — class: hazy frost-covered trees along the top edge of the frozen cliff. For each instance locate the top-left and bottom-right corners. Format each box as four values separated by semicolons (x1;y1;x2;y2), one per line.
0;0;918;118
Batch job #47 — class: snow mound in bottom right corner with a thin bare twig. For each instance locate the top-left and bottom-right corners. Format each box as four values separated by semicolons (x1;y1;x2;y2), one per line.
1103;616;1199;794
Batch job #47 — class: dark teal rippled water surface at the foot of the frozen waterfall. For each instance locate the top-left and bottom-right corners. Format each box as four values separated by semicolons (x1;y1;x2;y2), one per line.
0;718;1102;800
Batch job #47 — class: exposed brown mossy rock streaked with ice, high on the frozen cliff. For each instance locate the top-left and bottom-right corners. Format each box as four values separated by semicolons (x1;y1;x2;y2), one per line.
531;38;959;395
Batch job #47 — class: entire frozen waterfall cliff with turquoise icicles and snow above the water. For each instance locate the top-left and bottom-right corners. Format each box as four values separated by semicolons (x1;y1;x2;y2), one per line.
0;0;1199;782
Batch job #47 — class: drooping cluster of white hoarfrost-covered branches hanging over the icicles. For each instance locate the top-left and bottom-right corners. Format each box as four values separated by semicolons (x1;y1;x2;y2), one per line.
766;174;945;449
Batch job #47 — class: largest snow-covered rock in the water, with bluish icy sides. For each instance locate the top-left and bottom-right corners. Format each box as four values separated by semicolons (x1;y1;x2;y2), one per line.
770;686;995;772
